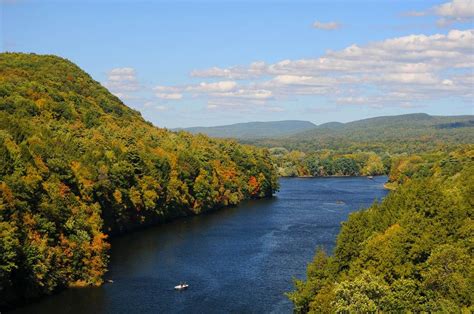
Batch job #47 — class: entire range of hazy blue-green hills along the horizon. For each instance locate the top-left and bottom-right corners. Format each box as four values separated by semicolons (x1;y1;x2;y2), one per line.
176;113;474;140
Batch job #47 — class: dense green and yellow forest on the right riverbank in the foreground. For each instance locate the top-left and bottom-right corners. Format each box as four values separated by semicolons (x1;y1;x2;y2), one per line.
288;145;474;313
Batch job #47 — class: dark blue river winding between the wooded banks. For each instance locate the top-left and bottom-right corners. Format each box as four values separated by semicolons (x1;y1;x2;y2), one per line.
15;177;387;313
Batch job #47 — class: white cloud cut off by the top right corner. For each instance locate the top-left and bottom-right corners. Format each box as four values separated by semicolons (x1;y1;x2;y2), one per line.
406;0;474;27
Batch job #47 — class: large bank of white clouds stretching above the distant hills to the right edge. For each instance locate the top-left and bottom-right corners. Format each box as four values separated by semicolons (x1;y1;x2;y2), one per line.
175;30;474;109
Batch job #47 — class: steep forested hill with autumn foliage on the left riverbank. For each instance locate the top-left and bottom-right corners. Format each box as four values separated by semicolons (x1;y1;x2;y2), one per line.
0;53;277;309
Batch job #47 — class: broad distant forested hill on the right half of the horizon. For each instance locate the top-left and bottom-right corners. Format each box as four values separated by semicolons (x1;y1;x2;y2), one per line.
248;113;474;153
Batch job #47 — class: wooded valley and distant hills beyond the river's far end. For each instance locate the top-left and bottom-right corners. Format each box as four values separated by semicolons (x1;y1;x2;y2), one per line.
198;113;474;178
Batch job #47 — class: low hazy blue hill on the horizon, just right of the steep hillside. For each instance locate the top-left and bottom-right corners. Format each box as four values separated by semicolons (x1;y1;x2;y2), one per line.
178;120;316;139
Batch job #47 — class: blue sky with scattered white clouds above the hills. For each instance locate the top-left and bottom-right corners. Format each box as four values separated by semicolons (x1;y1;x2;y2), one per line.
0;0;474;128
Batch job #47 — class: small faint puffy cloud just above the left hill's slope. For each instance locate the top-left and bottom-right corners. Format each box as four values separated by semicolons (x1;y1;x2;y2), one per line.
103;67;141;100
